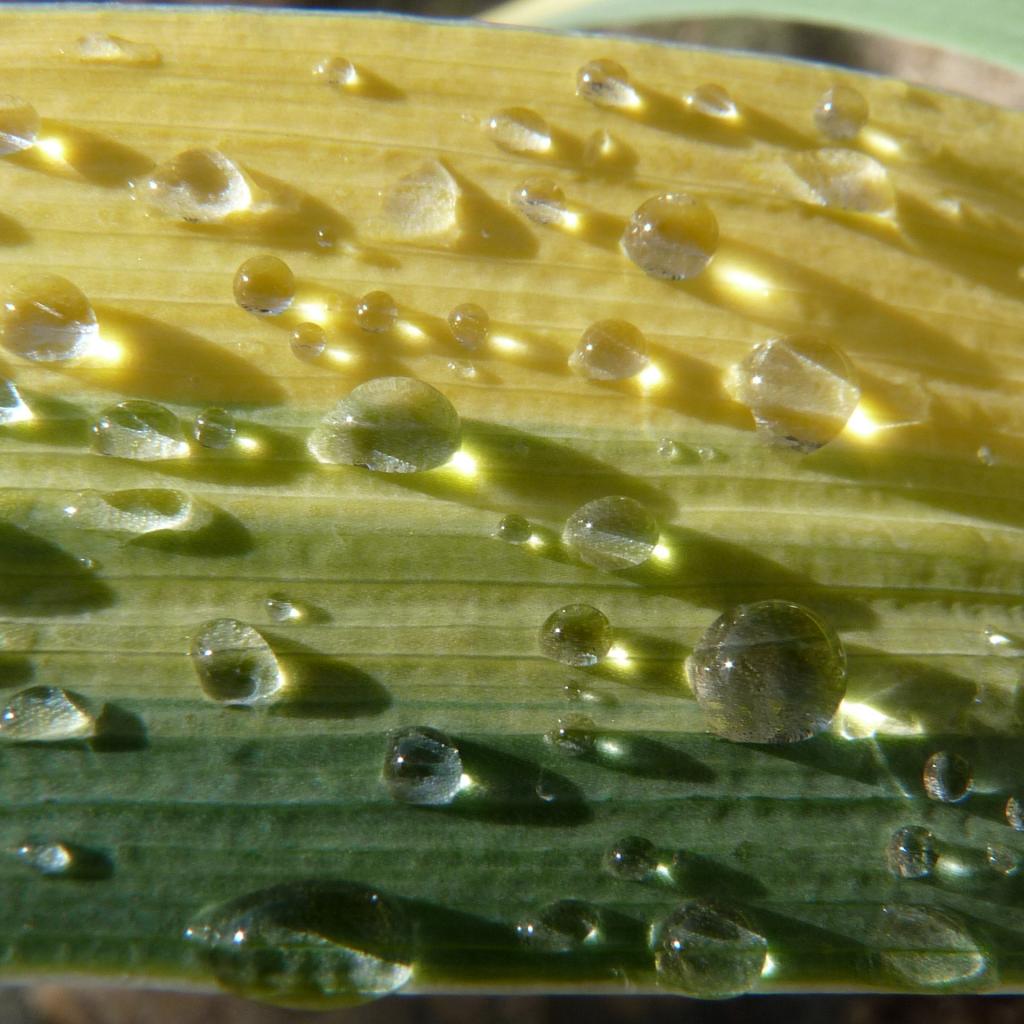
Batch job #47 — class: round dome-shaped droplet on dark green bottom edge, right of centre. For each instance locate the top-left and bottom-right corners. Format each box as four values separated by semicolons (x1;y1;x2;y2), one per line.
651;900;768;999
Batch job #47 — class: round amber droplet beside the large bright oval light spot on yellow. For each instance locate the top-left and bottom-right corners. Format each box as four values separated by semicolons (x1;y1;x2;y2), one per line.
622;193;718;281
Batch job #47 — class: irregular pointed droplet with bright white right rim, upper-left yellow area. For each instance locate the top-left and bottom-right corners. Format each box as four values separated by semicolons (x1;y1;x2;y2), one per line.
136;150;253;223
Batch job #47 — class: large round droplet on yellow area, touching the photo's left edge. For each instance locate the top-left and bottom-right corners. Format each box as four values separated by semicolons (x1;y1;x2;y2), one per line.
0;273;99;362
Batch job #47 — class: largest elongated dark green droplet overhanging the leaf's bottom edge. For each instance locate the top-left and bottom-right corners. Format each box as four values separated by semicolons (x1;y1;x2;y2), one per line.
184;882;413;1009
